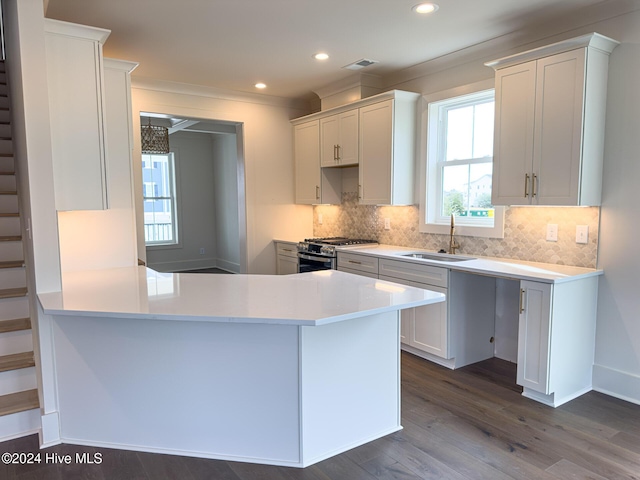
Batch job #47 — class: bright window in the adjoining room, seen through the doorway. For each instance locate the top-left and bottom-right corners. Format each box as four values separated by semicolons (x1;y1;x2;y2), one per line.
142;153;178;245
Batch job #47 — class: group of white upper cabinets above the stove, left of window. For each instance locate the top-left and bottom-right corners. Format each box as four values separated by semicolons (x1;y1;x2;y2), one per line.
291;90;420;205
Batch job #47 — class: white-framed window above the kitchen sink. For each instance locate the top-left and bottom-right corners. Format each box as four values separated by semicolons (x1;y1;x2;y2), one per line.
420;86;504;238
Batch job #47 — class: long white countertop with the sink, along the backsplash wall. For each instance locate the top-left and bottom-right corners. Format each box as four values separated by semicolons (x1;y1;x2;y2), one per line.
337;245;604;283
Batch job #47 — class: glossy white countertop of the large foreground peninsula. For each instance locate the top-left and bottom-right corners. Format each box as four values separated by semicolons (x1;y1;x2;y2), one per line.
38;267;444;326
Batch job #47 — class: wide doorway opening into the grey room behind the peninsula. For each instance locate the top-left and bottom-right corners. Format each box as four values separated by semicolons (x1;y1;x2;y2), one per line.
138;112;247;273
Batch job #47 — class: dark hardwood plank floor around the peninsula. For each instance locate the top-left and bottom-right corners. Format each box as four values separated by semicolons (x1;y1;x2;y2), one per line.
0;353;640;480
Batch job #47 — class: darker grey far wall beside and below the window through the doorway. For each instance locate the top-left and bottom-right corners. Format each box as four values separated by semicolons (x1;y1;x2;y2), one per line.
145;131;216;272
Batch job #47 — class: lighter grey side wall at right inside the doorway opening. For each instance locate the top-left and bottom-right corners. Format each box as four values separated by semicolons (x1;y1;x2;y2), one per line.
212;134;240;273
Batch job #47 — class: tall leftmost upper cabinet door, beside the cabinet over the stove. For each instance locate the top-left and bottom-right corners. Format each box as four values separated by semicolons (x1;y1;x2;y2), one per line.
293;120;320;205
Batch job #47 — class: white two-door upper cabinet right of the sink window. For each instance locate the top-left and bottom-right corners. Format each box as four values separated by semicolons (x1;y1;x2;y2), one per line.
486;33;618;206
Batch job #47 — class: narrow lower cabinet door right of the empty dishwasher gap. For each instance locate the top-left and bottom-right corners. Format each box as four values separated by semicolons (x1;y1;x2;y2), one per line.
517;280;552;394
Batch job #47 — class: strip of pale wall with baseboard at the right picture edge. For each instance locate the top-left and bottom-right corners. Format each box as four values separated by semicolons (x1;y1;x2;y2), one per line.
594;11;640;403
